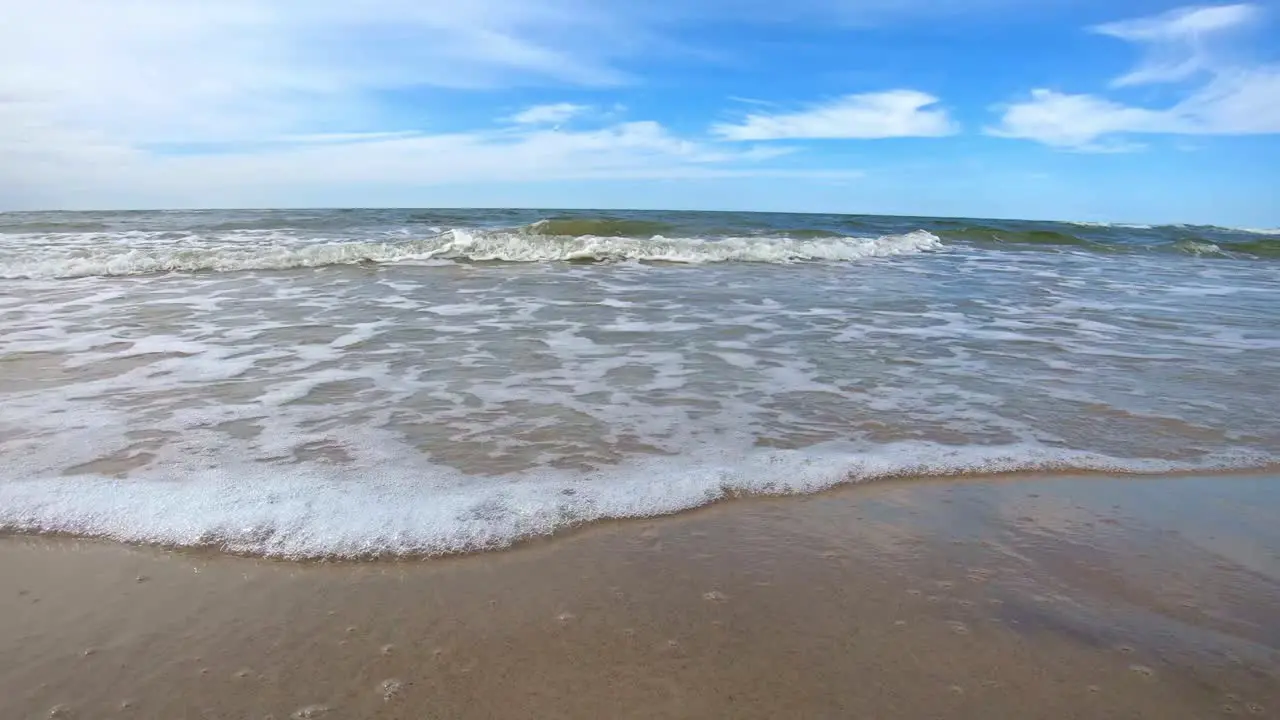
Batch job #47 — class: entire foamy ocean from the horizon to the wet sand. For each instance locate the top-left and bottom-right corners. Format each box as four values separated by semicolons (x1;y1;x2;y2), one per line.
0;210;1280;559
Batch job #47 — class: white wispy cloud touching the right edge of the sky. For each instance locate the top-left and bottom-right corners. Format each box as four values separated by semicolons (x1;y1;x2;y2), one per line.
987;5;1280;152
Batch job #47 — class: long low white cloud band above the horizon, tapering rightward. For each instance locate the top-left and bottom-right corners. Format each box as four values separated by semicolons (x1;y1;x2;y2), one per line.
0;112;834;208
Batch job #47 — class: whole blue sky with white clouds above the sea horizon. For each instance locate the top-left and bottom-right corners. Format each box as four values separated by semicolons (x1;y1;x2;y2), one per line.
0;0;1280;228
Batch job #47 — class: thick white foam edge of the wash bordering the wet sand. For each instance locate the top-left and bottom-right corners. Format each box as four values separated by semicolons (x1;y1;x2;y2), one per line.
0;442;1275;559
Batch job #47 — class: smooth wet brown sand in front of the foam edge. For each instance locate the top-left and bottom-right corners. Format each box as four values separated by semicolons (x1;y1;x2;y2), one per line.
0;475;1280;720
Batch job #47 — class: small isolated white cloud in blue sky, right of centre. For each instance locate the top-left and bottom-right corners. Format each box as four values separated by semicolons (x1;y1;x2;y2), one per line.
712;90;957;140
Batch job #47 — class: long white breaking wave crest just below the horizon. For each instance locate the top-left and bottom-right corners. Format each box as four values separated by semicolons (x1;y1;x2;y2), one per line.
0;224;942;279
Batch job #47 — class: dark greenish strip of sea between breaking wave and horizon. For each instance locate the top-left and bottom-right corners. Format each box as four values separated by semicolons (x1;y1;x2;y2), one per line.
0;210;1280;269
